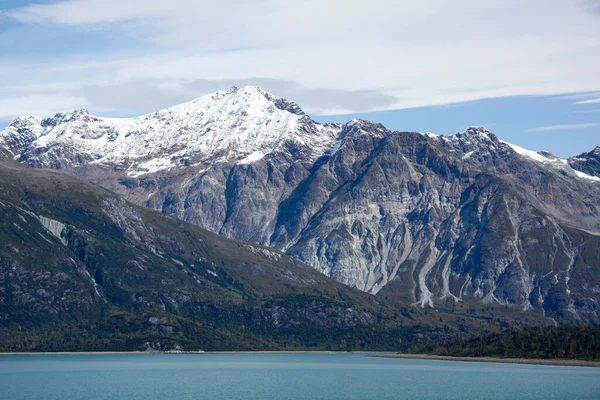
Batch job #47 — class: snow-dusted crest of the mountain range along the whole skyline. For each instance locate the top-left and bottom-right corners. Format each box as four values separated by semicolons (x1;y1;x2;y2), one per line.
0;86;600;185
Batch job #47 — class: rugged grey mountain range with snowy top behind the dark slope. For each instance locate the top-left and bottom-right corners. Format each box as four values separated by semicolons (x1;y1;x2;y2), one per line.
0;88;600;321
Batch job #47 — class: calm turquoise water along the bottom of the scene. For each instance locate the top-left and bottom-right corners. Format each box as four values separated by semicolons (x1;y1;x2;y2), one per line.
0;354;600;400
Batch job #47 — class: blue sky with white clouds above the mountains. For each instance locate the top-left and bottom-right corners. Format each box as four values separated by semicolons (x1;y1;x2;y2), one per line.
0;0;600;157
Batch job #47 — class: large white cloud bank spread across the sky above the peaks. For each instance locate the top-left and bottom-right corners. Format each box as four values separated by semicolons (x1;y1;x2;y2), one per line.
0;0;600;113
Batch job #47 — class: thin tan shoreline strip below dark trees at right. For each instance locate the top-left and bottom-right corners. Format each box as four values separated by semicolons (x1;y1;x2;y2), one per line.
376;354;600;368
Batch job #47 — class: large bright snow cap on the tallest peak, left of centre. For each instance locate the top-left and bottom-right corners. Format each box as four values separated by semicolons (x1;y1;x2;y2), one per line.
2;86;340;176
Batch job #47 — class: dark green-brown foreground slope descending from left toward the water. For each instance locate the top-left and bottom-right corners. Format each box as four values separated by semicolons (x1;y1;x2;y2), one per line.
0;158;422;350
